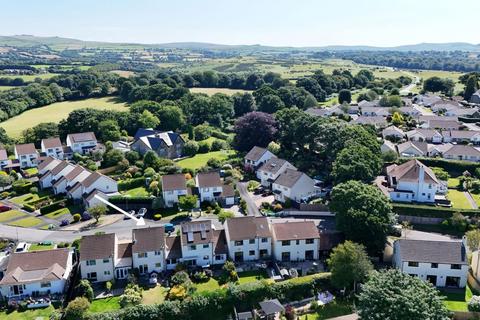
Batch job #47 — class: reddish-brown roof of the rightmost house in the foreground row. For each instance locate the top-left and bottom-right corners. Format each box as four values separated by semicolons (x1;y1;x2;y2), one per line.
272;221;320;241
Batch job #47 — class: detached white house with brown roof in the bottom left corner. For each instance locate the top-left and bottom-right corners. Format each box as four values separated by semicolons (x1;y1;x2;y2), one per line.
0;248;73;300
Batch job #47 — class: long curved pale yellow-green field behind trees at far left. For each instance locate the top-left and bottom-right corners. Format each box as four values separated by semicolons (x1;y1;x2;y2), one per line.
0;97;127;138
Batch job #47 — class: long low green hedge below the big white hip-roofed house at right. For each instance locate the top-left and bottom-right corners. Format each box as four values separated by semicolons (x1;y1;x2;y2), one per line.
392;203;479;219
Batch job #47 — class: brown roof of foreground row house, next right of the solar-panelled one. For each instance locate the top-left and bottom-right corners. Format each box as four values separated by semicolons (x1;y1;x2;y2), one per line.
226;217;272;241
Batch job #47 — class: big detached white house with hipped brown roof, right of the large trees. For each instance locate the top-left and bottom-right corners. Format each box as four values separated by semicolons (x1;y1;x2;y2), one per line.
387;160;440;203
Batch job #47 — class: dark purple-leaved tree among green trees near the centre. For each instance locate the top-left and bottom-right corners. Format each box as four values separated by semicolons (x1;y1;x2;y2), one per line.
234;111;277;151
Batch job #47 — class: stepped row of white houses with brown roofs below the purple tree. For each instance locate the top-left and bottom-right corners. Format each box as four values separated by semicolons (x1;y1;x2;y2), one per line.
244;146;318;202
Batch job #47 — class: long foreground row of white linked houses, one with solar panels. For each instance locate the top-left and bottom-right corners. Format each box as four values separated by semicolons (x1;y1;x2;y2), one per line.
80;217;320;282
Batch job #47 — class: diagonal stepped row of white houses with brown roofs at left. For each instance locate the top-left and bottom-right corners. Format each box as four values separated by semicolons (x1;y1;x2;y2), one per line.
38;156;118;207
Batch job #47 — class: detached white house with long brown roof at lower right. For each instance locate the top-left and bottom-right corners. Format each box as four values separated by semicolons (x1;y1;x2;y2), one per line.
393;239;469;288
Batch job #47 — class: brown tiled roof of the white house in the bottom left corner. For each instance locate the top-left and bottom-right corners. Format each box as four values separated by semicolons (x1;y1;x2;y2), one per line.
0;248;70;285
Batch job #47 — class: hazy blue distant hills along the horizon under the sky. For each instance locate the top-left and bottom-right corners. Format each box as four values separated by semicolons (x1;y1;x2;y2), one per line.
0;35;480;52
